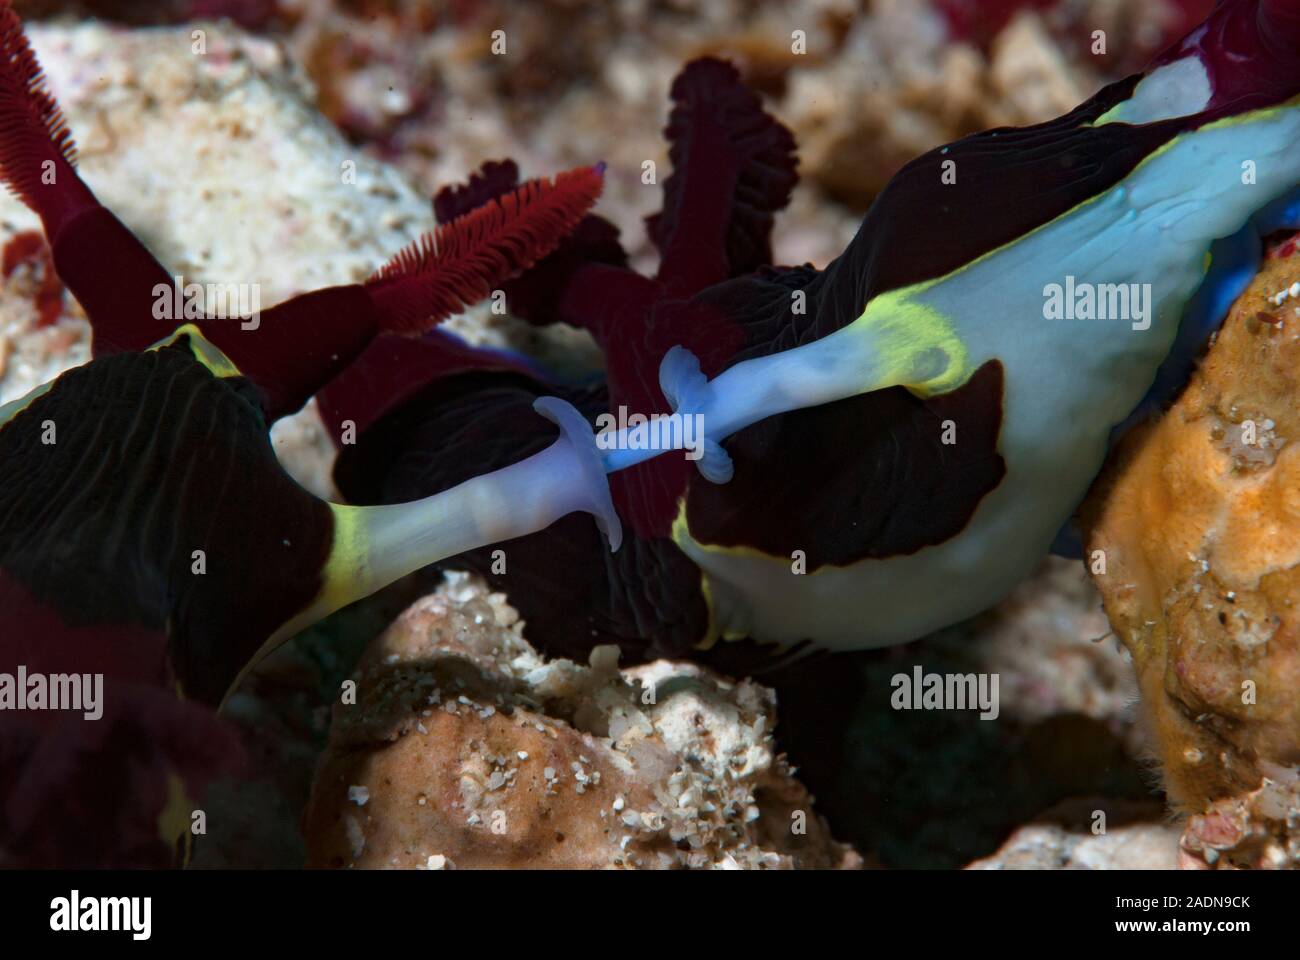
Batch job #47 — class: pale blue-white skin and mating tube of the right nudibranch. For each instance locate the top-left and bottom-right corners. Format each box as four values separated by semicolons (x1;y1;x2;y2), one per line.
679;22;1300;649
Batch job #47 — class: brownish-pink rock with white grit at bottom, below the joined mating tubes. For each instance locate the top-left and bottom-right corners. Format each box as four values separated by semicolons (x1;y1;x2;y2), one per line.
306;575;861;869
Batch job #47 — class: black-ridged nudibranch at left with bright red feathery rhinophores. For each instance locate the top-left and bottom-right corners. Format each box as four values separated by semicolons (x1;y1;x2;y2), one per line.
0;3;620;866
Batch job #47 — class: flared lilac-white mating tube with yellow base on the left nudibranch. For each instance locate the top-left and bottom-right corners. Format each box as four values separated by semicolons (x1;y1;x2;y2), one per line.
288;397;623;643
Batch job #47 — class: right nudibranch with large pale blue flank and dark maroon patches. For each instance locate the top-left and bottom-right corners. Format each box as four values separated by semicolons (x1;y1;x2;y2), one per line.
322;0;1300;670
